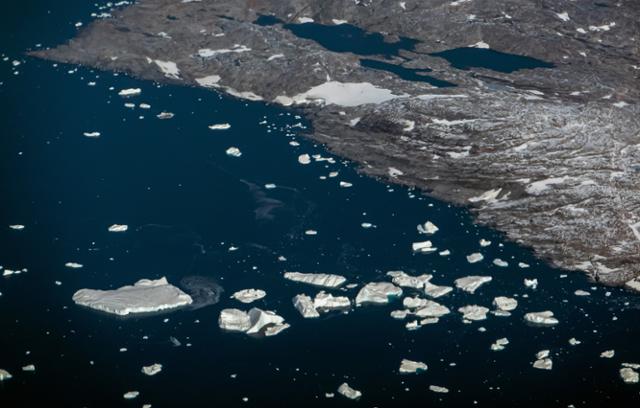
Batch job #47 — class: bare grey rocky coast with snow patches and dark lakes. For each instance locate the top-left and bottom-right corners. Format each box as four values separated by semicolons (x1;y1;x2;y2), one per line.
34;0;640;284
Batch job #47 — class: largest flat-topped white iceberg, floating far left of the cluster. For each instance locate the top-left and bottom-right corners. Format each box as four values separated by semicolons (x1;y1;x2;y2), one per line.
73;277;193;316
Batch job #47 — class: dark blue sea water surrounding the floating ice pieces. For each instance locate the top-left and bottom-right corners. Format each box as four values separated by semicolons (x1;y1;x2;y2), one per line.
0;0;640;408
